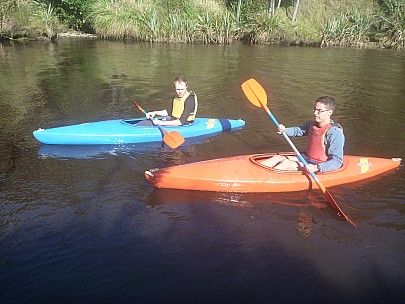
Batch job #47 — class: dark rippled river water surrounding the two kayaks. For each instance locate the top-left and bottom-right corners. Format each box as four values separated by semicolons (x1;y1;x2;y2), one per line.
0;40;405;304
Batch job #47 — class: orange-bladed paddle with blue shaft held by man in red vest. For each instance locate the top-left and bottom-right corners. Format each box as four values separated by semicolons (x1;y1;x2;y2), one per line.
241;78;356;226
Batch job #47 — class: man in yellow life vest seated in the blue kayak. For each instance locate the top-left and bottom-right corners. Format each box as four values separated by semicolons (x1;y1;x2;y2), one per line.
146;76;198;126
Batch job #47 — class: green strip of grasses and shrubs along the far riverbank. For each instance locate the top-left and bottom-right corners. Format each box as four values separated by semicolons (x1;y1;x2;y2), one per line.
0;0;405;49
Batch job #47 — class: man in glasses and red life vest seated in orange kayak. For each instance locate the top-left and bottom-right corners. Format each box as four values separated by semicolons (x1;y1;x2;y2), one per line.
263;96;345;172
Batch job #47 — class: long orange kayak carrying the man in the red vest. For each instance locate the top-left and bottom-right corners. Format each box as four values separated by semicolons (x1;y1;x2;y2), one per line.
145;153;401;193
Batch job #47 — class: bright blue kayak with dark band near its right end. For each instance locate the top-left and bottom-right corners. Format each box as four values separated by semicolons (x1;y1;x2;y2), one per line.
33;118;245;145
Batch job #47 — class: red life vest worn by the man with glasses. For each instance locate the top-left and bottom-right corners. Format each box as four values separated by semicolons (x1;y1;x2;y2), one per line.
306;123;342;163
